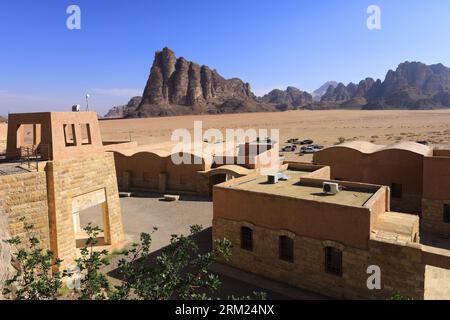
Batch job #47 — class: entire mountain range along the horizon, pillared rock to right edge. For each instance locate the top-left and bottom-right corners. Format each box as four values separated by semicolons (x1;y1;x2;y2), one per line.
105;48;450;118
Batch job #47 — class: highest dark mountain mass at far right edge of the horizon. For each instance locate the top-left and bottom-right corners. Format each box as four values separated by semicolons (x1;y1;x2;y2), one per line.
364;62;450;109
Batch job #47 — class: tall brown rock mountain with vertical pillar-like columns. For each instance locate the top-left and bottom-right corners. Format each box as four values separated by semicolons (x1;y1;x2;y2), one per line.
126;48;276;117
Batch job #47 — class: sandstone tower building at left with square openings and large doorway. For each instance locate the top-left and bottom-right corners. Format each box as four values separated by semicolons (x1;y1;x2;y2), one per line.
0;112;124;268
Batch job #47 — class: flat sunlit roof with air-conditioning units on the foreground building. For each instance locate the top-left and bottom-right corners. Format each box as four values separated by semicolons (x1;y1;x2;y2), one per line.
224;170;375;207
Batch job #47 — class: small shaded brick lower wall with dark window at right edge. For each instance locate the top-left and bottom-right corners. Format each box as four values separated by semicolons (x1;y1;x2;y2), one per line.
420;195;450;238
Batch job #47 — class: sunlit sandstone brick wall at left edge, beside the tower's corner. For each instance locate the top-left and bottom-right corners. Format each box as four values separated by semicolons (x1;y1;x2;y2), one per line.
0;172;49;248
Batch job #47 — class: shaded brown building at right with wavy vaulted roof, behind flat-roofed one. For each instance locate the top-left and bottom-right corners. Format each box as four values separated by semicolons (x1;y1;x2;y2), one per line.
314;141;450;238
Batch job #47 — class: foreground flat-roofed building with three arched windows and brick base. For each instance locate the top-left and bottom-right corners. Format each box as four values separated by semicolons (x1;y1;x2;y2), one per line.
213;151;450;299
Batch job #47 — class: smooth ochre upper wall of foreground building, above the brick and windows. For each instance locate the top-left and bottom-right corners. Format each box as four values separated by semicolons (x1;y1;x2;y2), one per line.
213;184;374;248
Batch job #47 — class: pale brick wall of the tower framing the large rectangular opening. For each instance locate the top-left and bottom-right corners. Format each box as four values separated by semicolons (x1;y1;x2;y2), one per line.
47;153;124;268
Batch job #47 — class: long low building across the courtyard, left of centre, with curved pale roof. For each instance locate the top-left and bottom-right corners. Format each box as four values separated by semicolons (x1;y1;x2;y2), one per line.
105;140;280;196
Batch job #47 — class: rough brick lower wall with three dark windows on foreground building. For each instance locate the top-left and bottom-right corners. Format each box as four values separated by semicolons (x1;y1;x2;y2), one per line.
213;218;425;299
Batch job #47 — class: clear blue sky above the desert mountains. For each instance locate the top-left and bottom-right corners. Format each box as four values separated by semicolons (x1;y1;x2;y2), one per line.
0;0;450;114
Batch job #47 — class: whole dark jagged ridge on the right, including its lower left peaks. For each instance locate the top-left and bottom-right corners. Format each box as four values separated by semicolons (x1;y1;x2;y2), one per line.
319;62;450;109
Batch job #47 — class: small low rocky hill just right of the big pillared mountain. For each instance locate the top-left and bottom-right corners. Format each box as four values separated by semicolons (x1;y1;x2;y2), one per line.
262;87;313;111
